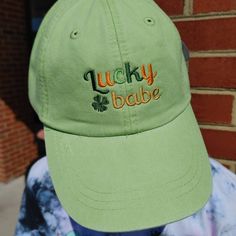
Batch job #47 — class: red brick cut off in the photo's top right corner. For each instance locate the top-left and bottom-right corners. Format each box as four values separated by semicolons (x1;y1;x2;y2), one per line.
193;0;236;13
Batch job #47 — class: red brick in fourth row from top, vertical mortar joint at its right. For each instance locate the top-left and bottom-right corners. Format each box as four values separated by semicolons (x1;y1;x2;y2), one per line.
191;94;234;124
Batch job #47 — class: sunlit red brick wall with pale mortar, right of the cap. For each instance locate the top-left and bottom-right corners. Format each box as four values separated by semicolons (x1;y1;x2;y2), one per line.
156;0;236;172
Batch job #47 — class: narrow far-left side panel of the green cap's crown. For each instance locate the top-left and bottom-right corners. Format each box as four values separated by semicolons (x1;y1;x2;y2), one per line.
29;0;82;122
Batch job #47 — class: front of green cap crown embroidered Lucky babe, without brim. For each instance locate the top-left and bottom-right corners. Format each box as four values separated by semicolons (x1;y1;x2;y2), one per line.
36;0;190;137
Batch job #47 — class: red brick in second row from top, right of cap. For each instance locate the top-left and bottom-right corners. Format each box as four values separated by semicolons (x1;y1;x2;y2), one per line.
175;17;236;51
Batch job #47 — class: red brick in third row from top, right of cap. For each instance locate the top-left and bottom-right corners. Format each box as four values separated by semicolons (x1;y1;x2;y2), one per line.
189;57;236;88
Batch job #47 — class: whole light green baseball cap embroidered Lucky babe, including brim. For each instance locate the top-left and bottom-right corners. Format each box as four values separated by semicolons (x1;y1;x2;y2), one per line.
29;0;212;232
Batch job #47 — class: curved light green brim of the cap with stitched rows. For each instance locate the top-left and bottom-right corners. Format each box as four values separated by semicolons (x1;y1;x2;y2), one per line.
45;104;212;232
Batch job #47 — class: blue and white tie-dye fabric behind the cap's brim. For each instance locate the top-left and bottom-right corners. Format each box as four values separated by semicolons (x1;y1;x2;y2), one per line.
15;157;236;236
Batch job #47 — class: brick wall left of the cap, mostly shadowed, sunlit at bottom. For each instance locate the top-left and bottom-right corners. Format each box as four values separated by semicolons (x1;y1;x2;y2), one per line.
0;0;37;182
